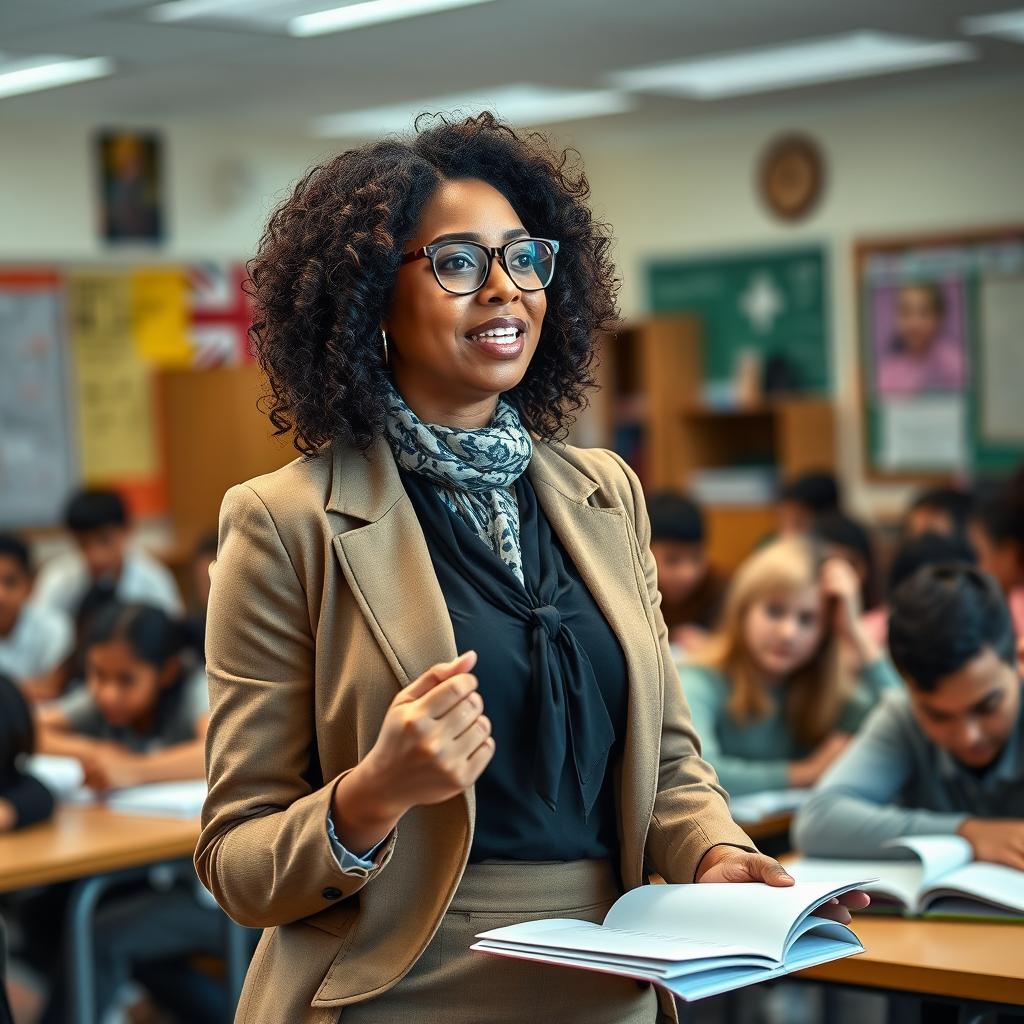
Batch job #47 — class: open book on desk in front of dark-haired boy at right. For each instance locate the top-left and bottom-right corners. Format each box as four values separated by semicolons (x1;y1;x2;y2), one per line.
785;836;1024;920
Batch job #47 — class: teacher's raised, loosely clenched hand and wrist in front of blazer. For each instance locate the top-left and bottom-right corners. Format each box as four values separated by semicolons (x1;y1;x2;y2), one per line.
333;651;495;852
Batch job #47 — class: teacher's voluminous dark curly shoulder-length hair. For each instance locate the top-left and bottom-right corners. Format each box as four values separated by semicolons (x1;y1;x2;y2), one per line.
247;113;618;455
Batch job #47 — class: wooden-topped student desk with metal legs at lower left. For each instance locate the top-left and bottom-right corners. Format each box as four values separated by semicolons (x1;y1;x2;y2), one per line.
0;805;248;1024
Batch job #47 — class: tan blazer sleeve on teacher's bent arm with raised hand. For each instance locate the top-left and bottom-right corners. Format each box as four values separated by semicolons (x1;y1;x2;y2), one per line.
196;484;395;928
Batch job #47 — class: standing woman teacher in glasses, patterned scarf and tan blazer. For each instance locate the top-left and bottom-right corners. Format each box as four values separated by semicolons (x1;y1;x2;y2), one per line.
196;115;863;1024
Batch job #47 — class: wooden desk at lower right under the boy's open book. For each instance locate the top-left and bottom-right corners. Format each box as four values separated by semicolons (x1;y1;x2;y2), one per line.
799;914;1024;1007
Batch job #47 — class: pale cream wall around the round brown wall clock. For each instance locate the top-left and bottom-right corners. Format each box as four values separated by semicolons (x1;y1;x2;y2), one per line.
578;76;1024;514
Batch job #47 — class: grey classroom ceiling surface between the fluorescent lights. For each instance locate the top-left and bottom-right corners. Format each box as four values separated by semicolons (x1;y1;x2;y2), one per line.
0;0;1024;133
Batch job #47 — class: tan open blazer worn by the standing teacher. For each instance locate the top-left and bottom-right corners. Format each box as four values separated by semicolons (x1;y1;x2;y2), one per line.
196;439;753;1024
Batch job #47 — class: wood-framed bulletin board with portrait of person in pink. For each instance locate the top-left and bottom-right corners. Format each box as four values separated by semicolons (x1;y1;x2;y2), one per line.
854;226;1024;481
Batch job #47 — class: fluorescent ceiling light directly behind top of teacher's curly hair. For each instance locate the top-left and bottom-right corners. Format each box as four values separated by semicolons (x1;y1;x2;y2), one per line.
312;84;633;138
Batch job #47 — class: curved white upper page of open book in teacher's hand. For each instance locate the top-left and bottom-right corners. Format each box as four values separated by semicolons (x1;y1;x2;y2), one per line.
604;871;864;963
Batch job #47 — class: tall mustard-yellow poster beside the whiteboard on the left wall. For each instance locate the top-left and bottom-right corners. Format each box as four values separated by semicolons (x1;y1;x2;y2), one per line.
68;270;166;514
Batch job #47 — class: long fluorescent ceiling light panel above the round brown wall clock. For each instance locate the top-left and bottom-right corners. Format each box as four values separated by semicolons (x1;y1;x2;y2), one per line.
609;32;974;99
